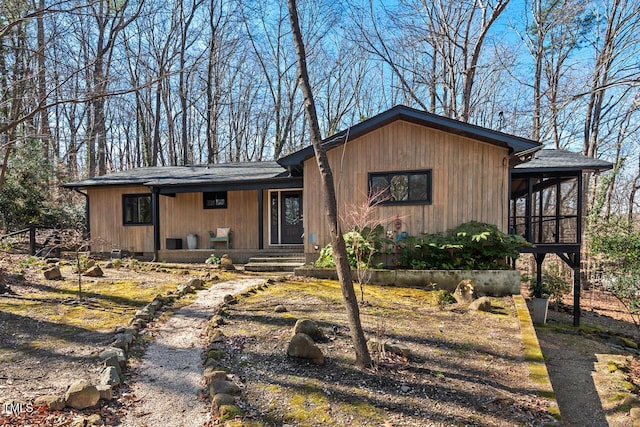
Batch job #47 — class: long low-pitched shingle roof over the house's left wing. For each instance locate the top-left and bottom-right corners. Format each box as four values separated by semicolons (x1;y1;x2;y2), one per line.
64;161;287;188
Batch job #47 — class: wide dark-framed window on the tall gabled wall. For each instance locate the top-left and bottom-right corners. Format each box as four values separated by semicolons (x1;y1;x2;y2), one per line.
369;170;431;205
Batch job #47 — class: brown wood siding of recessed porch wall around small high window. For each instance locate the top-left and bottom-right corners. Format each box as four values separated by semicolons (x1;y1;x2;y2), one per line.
160;190;258;251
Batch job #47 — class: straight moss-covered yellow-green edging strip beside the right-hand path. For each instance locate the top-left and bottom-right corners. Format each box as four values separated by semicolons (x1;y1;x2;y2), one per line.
513;295;562;421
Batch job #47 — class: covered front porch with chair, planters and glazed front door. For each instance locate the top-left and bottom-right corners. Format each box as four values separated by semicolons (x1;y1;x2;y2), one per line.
145;164;304;263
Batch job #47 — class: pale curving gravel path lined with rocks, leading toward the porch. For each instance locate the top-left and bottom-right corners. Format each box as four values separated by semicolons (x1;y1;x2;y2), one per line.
121;277;264;427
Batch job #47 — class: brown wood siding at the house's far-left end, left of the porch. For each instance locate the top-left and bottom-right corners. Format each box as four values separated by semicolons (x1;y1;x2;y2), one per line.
87;186;153;253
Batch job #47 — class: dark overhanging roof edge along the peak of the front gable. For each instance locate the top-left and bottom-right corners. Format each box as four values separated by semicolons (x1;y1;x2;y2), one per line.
278;105;540;167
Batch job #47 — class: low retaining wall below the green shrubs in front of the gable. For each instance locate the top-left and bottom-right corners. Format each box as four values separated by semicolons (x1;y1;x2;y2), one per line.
295;266;520;297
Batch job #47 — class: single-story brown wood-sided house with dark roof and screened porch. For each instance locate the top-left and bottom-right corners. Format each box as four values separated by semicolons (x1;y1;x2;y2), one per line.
65;106;611;270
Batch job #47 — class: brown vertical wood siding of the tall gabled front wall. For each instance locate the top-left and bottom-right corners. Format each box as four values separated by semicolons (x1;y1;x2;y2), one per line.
304;121;508;253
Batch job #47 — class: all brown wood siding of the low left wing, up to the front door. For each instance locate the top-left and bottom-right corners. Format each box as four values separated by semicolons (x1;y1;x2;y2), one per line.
87;186;268;253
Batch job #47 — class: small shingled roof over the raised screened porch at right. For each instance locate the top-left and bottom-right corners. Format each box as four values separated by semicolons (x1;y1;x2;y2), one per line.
513;149;613;174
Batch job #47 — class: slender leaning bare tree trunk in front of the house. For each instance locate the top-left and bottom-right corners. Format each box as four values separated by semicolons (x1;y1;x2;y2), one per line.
288;0;371;368
